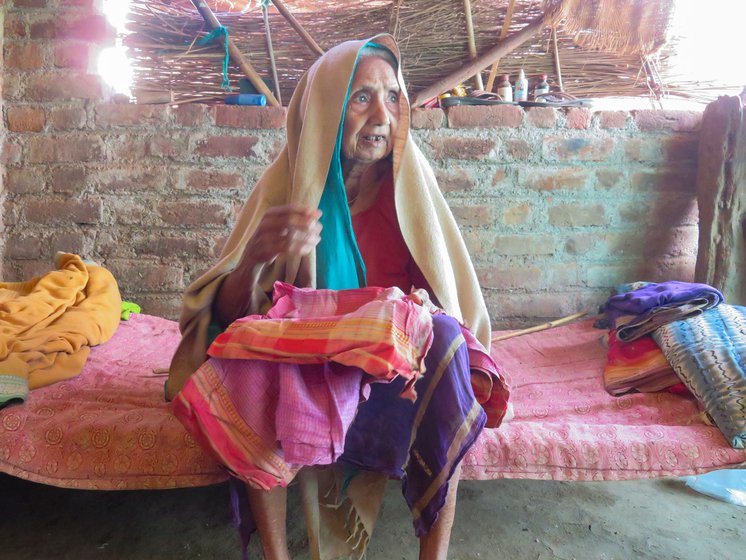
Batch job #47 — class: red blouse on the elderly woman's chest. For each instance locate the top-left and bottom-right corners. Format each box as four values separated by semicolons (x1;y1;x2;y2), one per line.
352;174;432;294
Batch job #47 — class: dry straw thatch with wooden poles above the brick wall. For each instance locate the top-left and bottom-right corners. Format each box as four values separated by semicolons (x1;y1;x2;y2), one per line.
120;0;692;103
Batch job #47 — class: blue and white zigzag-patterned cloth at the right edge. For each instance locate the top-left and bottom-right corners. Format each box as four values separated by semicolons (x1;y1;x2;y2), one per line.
653;304;746;449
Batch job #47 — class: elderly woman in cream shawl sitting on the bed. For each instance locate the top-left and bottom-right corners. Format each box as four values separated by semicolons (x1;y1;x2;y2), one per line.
166;35;507;558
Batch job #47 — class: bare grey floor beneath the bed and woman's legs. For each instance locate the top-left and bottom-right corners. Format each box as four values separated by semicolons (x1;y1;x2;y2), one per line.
0;475;746;560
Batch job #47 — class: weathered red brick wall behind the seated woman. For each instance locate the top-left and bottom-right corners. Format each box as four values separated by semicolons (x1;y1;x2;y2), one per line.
3;0;701;326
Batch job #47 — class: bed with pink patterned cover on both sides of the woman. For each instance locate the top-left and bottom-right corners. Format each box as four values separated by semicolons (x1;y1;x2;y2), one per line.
0;314;746;490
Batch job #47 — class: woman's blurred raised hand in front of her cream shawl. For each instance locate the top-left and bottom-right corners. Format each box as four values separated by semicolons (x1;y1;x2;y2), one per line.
241;205;321;268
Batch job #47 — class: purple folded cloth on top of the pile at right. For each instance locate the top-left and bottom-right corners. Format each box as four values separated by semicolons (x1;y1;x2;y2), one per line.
603;280;725;334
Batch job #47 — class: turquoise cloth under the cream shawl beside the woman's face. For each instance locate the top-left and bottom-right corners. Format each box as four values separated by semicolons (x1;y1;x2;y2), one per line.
316;43;396;290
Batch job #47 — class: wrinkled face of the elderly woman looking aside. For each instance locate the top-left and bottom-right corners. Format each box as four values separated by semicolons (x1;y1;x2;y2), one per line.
342;56;401;164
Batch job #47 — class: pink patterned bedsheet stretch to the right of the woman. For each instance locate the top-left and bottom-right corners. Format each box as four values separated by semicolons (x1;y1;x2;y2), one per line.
462;321;746;480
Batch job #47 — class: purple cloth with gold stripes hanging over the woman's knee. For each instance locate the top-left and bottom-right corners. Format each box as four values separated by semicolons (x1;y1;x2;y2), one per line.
339;315;487;537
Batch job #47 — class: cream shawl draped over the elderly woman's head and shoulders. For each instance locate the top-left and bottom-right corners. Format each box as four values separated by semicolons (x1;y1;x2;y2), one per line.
166;34;490;399
